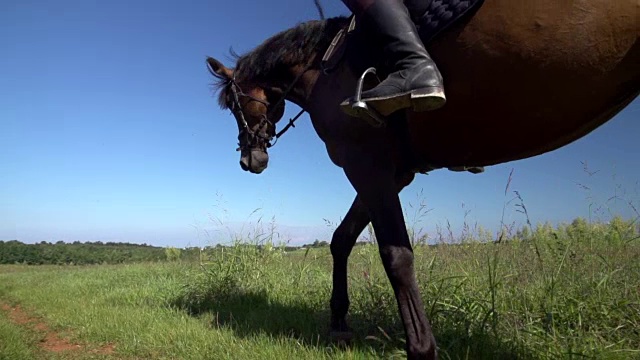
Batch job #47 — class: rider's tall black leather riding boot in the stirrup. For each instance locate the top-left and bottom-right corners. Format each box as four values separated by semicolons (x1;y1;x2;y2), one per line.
340;0;446;116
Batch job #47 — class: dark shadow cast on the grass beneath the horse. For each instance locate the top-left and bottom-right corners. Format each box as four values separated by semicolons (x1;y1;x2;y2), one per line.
172;288;536;360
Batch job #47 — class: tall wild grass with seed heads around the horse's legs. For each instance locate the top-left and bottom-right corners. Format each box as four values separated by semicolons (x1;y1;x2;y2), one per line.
168;218;640;359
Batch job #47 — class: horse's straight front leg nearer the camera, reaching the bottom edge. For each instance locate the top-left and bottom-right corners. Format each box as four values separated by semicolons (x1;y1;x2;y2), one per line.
343;150;437;359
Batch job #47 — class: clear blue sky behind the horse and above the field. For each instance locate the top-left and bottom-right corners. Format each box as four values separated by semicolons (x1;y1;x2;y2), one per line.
0;0;640;246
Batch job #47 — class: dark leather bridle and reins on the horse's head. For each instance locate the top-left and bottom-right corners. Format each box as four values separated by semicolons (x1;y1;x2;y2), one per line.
229;63;311;151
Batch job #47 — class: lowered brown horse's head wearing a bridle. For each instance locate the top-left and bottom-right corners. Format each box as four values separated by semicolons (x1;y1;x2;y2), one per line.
207;57;284;174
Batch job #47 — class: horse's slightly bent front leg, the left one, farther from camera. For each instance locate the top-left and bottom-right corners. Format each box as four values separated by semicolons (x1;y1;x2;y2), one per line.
330;196;369;342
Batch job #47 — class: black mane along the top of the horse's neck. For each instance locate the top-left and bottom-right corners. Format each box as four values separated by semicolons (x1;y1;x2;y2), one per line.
213;16;349;109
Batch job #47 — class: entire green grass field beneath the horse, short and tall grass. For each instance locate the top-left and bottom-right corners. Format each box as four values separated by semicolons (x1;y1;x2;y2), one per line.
0;219;640;360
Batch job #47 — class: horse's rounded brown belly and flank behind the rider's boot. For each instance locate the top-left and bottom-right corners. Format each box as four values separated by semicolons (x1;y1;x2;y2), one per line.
411;0;640;164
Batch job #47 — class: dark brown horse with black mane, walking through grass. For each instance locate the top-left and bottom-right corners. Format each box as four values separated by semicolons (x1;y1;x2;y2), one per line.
207;0;640;359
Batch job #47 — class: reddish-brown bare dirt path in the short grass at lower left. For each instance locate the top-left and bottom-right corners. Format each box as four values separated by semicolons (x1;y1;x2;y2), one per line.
0;303;115;355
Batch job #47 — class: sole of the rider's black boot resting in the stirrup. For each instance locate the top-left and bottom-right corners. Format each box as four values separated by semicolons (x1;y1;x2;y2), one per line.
340;87;447;121
